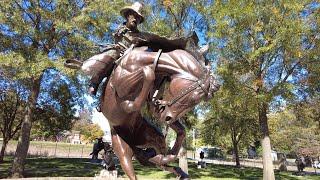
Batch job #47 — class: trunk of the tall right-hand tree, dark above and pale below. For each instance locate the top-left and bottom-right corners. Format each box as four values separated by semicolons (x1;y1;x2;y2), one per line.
259;103;275;180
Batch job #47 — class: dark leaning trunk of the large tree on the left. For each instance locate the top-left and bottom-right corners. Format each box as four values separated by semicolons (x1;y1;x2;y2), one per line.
11;78;41;178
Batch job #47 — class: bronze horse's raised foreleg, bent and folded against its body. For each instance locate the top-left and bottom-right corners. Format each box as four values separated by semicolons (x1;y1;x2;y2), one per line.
121;66;155;113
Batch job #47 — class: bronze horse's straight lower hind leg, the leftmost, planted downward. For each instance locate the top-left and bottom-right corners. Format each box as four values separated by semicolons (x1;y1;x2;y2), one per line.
111;131;137;180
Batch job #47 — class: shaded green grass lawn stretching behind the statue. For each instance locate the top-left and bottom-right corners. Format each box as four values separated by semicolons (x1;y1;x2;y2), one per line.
0;158;320;180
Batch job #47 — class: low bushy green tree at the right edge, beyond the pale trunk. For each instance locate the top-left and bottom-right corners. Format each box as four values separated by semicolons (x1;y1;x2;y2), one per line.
269;98;320;157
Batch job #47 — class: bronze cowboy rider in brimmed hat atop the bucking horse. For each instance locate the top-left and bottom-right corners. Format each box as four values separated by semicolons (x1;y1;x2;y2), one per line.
70;2;203;95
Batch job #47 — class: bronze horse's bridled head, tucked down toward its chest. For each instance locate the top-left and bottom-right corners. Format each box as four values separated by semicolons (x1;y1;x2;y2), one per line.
160;71;220;123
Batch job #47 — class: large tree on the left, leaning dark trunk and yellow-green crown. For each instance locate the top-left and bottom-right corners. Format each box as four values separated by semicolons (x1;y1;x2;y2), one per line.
0;0;123;177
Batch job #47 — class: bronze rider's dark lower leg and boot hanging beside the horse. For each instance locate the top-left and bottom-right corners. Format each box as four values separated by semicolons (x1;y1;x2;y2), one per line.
88;56;115;95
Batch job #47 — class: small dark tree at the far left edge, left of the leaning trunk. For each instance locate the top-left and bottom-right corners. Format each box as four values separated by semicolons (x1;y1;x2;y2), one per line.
0;89;25;163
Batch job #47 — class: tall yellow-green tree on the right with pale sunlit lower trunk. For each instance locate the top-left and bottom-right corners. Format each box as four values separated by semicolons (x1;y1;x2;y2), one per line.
208;0;319;179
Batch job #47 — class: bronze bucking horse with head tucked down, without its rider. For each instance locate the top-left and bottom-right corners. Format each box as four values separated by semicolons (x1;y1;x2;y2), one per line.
101;47;219;179
